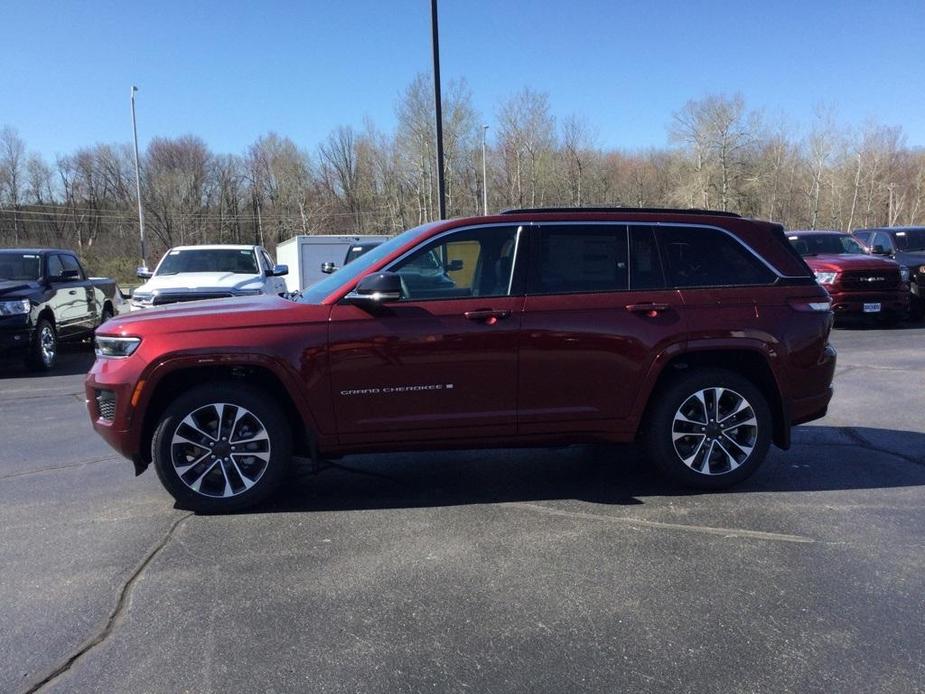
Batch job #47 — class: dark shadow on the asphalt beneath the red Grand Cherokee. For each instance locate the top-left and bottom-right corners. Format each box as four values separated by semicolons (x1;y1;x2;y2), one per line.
244;427;925;513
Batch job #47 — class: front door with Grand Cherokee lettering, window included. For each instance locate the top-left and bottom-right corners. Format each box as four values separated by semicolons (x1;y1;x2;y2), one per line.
329;225;523;443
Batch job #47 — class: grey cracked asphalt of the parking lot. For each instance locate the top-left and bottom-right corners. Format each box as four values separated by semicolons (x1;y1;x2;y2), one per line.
0;326;925;692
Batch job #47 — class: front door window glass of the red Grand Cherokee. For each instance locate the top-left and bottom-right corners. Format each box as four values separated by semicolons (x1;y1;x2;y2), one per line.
388;227;517;300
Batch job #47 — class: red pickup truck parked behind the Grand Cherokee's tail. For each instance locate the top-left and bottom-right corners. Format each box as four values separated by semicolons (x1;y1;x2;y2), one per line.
787;230;911;324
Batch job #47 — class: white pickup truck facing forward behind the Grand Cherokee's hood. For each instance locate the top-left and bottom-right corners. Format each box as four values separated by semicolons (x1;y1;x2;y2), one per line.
132;245;289;311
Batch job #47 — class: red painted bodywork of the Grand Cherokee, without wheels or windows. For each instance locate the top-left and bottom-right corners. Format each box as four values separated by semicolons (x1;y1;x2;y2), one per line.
86;212;835;468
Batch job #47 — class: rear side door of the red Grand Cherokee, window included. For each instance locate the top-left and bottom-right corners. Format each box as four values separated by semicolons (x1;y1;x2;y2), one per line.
518;222;684;434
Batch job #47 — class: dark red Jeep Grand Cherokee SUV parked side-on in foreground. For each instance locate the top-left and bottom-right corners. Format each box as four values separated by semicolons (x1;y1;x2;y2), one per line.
86;208;835;511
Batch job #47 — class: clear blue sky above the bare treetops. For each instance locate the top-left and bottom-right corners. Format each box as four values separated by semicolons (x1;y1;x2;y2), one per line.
0;0;925;157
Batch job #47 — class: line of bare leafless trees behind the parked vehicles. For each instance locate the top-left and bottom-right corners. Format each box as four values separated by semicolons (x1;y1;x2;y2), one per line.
0;75;925;280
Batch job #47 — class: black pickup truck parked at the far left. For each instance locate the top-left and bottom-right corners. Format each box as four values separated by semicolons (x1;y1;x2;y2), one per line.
0;248;122;371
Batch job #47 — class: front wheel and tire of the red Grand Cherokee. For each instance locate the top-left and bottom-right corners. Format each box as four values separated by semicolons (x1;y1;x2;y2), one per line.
151;382;292;513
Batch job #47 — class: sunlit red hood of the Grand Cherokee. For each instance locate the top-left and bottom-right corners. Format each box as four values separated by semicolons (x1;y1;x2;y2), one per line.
97;294;331;337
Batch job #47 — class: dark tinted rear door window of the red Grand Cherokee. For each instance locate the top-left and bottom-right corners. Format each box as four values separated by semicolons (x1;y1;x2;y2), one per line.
529;224;629;294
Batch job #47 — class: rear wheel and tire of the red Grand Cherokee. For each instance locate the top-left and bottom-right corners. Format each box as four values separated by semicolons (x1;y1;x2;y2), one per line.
644;369;773;489
